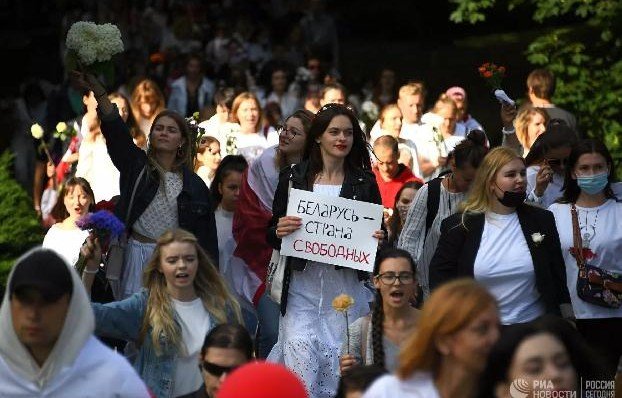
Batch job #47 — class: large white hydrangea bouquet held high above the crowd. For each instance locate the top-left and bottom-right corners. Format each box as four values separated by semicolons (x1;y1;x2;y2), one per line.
65;21;123;84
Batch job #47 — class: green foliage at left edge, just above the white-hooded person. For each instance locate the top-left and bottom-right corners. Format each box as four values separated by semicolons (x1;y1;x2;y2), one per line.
0;151;43;284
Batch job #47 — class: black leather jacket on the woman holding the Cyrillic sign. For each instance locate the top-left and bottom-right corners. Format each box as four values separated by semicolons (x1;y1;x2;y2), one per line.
267;161;385;314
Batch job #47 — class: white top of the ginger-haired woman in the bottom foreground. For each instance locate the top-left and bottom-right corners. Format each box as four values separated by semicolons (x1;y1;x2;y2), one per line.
363;372;440;398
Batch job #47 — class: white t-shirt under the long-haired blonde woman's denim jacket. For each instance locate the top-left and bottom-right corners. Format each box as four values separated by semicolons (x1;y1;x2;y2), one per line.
171;298;212;397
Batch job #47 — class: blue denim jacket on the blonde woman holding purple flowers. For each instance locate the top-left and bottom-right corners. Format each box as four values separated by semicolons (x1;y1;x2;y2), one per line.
91;289;216;398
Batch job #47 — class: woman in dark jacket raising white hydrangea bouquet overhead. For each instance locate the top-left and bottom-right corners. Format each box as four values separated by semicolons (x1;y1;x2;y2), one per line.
73;71;218;298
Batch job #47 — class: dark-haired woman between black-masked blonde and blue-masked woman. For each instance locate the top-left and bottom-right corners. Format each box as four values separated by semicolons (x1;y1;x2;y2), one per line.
525;119;577;209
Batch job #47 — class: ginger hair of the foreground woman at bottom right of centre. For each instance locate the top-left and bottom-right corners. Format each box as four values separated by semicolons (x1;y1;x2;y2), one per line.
397;278;496;379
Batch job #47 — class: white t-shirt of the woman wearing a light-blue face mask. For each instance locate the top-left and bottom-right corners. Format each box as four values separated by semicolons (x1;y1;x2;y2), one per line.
545;199;622;319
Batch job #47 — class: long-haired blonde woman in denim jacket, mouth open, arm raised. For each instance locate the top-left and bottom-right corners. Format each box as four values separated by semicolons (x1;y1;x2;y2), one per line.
81;229;240;398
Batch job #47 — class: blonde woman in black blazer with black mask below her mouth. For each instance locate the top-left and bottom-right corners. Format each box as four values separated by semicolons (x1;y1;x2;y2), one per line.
430;147;572;325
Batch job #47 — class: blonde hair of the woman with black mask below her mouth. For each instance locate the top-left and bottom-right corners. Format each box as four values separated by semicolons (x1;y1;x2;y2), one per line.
460;147;525;216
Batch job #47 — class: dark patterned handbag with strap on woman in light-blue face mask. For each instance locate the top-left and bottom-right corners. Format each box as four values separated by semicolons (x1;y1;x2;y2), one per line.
570;203;622;308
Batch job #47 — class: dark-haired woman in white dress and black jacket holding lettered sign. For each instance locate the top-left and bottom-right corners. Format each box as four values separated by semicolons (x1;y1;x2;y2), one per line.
267;104;385;398
